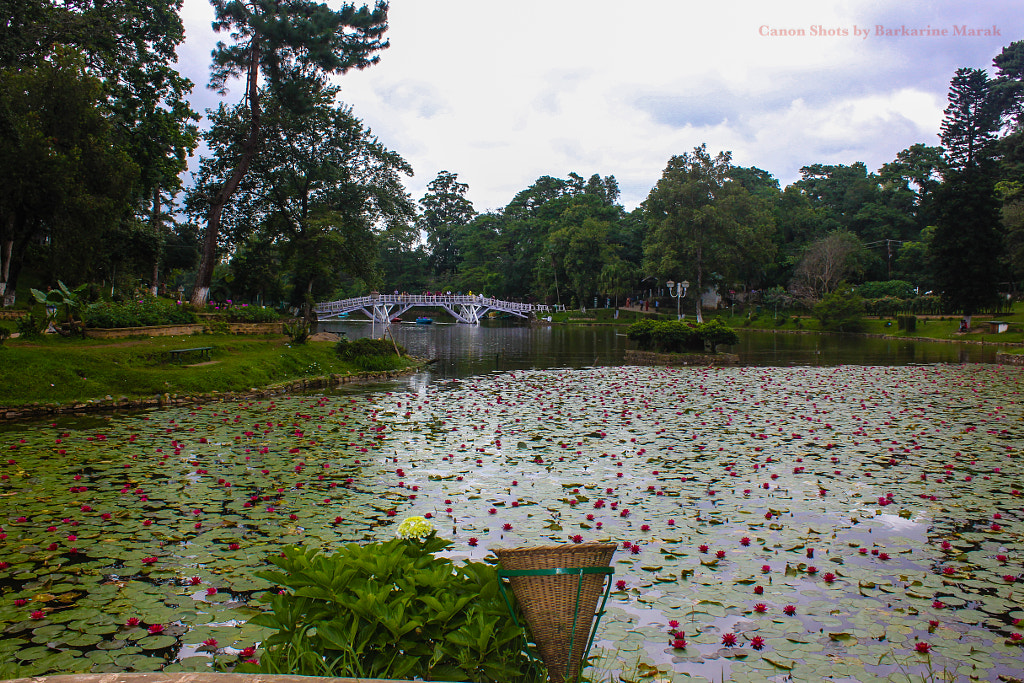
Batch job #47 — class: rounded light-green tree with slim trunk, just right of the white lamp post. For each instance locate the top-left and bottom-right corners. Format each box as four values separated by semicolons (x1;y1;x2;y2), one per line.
642;144;774;322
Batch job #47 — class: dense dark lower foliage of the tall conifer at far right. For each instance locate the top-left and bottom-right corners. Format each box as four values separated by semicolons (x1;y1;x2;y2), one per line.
929;166;1002;319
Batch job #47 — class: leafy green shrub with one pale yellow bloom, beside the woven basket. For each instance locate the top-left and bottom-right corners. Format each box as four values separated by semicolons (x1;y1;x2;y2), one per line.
234;518;544;683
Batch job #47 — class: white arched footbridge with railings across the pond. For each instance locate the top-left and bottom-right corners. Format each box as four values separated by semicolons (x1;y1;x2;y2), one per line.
314;294;550;325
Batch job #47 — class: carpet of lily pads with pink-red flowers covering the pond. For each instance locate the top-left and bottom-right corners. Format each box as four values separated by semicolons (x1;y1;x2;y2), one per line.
0;366;1024;681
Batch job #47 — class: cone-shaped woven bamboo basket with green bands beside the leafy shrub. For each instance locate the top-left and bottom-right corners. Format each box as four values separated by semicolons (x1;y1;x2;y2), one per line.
495;543;615;683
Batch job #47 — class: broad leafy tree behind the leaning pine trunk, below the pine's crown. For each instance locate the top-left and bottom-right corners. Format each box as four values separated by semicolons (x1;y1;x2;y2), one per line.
193;88;413;313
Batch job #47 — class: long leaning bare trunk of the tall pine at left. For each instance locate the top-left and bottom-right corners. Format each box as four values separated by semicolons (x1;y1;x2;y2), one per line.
191;38;260;306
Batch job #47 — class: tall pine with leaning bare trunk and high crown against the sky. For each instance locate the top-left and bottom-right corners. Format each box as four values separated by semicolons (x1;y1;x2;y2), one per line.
191;0;388;305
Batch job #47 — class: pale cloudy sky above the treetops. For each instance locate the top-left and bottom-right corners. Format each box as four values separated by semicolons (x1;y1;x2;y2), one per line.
178;0;1024;212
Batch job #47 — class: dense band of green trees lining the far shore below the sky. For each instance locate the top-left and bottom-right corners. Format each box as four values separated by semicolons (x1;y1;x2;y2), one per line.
0;5;1024;315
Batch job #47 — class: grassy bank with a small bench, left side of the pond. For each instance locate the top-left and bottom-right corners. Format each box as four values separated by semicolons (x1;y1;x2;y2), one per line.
0;335;414;408
